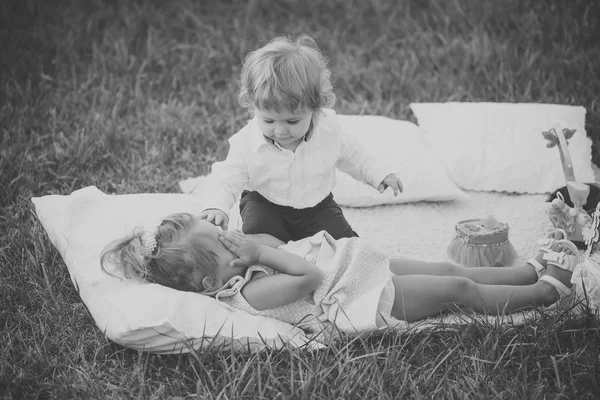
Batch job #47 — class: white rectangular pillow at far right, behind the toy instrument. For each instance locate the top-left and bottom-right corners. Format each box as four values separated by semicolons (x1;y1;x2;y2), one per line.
410;103;594;193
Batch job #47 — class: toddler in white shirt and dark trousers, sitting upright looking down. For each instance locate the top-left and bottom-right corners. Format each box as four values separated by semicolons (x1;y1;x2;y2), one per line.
201;36;403;242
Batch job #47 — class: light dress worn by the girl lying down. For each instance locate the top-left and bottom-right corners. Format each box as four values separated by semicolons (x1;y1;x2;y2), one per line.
215;231;399;333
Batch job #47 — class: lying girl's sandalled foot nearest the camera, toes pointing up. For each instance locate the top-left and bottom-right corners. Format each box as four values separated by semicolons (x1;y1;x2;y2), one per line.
539;240;579;304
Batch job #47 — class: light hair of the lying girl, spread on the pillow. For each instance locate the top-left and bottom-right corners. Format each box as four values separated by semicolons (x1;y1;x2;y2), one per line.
101;213;217;293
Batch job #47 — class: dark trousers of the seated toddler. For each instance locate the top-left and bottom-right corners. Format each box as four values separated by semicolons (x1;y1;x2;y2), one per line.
240;190;358;243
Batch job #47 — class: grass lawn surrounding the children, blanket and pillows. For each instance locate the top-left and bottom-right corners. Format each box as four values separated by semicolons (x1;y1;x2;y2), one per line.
0;0;600;399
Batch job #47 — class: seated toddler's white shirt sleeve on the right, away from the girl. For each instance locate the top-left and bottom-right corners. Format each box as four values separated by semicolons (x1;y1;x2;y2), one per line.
331;116;393;188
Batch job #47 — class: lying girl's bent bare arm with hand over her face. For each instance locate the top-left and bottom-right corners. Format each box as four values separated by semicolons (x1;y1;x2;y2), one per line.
219;231;323;310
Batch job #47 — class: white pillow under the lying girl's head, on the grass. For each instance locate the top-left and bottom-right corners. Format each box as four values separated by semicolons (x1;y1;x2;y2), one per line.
32;186;321;353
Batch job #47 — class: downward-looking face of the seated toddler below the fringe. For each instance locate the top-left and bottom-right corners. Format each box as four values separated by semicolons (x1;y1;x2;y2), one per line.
255;109;313;151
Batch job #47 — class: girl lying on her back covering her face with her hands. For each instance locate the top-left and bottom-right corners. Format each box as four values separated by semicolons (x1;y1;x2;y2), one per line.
102;214;578;333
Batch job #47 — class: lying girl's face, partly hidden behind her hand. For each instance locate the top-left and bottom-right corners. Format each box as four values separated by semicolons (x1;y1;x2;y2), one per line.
193;219;248;285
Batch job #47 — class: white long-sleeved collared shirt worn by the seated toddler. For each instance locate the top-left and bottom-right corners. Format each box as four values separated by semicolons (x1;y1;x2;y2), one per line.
202;109;391;214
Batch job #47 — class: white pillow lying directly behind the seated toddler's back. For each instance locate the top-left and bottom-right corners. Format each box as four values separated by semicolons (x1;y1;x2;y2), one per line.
179;115;468;208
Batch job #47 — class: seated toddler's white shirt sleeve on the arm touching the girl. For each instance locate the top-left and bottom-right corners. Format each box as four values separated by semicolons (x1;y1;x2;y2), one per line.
202;126;249;215
